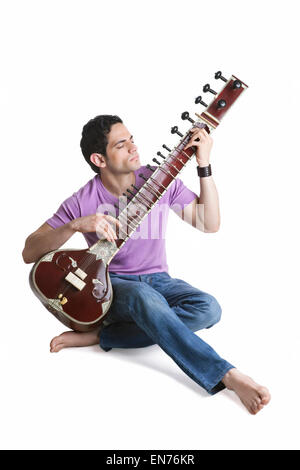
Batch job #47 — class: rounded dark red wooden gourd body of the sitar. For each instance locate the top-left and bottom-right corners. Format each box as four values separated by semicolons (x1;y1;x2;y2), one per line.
29;250;113;331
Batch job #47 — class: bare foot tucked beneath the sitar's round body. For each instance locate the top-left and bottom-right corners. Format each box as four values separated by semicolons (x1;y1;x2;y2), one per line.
50;329;99;352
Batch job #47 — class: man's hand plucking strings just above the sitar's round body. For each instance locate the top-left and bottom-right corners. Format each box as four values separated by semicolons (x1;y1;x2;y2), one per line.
69;213;121;242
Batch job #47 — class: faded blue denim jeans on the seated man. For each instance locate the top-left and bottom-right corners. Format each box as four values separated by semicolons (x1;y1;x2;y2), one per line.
100;272;234;395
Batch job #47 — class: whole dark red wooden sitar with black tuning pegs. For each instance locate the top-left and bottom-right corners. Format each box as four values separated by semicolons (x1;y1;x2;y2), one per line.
29;71;248;331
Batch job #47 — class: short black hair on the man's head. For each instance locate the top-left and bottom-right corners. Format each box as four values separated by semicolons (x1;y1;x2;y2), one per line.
80;114;123;173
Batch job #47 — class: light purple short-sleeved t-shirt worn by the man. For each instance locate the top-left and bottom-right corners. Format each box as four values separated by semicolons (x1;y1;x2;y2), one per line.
46;166;197;274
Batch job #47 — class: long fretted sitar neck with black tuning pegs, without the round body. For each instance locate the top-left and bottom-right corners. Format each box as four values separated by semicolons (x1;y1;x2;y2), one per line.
88;74;247;264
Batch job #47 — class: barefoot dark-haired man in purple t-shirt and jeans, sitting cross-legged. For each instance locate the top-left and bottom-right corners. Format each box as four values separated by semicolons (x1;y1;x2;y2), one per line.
23;115;270;414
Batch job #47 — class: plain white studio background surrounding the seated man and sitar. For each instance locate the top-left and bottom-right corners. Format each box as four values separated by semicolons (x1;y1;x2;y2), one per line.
0;0;300;450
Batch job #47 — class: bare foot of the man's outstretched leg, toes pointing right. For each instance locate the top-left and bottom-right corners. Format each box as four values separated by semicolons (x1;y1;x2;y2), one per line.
222;368;271;415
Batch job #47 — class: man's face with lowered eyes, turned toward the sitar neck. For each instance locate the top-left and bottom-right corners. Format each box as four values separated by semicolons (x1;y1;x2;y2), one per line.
99;123;141;173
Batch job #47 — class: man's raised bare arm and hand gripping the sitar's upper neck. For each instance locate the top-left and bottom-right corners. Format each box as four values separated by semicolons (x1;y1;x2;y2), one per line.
176;128;220;233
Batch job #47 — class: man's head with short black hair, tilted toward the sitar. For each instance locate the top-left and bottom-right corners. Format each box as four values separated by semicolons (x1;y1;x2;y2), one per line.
80;114;141;174
